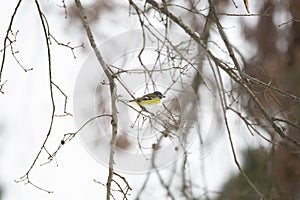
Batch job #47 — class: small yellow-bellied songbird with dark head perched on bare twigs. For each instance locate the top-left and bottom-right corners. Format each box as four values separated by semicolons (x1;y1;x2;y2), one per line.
129;91;166;109
